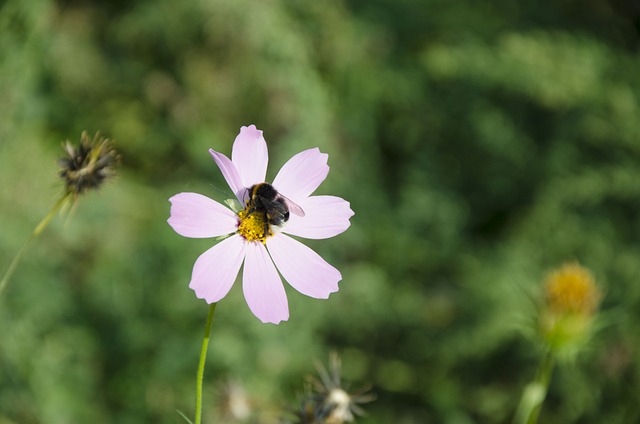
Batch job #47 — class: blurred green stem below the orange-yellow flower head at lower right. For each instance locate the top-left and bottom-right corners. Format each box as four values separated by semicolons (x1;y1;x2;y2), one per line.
513;350;555;424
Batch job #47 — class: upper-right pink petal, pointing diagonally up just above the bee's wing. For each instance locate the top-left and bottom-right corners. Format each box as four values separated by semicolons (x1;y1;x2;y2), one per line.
273;147;329;206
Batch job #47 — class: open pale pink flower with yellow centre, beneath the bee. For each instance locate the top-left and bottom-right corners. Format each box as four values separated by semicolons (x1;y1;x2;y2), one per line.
168;125;353;324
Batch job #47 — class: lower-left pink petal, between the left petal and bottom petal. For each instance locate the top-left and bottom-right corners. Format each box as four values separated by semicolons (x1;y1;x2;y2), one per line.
189;235;245;303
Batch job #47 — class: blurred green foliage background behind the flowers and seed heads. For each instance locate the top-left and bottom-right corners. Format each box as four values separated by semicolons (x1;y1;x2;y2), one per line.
0;0;640;424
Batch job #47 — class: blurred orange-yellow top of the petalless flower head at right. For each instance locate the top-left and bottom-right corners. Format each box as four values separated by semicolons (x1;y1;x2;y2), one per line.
545;262;600;315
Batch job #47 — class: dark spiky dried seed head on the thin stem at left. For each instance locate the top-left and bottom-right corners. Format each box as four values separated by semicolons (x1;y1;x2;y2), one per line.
58;131;120;197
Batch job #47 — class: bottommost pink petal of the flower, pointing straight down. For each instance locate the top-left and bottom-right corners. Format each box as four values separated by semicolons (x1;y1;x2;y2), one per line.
242;243;289;324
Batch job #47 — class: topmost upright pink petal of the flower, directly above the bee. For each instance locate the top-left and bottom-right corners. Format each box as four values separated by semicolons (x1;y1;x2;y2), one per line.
231;125;269;190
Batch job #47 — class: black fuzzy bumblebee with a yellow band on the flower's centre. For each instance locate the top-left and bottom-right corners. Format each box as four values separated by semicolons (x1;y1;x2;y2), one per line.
247;183;304;237
